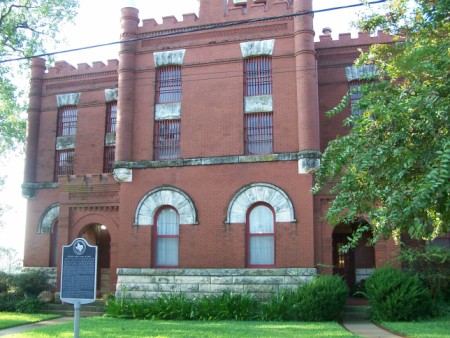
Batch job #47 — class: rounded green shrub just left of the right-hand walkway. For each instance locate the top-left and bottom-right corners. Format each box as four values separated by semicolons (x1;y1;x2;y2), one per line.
294;275;349;322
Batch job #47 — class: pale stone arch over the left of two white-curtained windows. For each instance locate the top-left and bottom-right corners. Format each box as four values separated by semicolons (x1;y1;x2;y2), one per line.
134;187;197;226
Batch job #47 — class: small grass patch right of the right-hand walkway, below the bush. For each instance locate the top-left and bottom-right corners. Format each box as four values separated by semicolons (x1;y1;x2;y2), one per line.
381;314;450;338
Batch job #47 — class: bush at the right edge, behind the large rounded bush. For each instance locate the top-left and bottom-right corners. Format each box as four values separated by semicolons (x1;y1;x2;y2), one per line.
398;246;450;302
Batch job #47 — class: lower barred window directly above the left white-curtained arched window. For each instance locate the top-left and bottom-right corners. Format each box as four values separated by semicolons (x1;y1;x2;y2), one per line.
154;120;180;160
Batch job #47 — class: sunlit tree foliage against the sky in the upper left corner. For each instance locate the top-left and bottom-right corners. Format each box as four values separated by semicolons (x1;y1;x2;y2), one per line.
0;0;78;156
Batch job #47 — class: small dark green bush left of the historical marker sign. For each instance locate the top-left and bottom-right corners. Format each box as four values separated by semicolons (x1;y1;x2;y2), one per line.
13;270;51;297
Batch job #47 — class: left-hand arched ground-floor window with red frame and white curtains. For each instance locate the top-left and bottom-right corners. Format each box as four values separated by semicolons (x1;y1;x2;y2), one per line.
154;206;180;267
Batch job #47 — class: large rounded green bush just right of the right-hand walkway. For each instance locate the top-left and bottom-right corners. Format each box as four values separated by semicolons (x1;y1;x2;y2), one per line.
366;265;433;321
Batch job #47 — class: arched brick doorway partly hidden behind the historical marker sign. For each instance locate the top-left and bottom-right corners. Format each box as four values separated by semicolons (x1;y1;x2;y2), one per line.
78;224;111;294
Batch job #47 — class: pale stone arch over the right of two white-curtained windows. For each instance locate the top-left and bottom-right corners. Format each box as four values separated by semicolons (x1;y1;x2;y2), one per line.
225;183;295;223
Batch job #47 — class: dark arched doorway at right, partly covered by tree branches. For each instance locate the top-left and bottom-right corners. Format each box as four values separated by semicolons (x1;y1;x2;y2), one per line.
333;223;375;289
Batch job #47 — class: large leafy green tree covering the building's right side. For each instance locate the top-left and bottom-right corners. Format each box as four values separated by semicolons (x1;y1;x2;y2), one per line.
313;0;450;244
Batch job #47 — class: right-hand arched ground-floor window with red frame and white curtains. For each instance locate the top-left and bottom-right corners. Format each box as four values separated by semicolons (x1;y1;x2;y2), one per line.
247;204;275;267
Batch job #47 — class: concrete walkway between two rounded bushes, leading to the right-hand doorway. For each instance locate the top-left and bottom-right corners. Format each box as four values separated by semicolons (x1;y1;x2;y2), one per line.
342;305;402;338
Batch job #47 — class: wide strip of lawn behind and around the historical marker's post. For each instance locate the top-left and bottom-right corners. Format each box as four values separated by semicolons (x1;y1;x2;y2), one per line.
2;317;354;338
